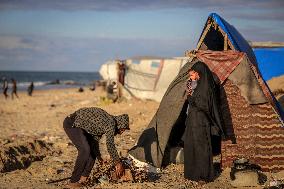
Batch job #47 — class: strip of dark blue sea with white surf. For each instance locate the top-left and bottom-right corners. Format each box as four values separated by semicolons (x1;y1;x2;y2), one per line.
0;71;102;91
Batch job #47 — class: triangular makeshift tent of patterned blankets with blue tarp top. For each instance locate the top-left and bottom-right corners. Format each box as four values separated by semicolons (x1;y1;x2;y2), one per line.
129;13;284;170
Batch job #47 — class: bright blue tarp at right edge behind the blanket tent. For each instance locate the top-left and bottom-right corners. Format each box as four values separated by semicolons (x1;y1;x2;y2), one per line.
254;47;284;81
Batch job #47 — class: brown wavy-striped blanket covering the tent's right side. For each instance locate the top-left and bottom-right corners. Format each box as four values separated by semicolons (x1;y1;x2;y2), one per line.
221;80;284;171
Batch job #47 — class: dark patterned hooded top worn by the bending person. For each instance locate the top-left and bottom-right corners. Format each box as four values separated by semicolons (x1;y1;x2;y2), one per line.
70;107;129;162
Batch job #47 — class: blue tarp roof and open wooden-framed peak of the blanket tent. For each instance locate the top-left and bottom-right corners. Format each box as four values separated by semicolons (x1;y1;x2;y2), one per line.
186;13;284;122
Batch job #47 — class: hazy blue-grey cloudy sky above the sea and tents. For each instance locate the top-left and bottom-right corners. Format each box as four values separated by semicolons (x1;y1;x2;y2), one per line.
0;0;284;72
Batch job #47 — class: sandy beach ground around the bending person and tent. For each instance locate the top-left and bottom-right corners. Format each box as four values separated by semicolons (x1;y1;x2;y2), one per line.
0;76;284;188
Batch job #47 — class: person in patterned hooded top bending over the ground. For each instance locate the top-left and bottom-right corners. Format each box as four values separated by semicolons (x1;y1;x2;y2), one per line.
63;107;129;188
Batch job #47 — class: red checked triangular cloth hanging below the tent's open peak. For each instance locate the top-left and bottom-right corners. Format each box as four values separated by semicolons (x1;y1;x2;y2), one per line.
196;50;245;84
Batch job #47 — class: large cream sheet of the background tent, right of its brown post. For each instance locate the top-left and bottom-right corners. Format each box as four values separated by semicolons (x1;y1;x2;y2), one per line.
124;59;187;102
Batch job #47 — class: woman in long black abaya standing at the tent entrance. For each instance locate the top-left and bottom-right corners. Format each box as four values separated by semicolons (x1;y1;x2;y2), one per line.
183;62;223;182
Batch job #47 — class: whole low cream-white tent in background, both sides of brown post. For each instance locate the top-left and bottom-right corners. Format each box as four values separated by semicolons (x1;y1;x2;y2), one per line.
100;57;188;102
